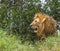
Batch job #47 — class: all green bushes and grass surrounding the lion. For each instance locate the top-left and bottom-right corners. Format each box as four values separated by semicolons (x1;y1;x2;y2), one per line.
0;0;60;51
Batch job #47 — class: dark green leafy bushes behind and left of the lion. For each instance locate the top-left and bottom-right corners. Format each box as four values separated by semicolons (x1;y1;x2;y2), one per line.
0;0;60;35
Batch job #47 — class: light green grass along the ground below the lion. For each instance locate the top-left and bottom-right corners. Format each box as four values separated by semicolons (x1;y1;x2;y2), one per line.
0;30;60;51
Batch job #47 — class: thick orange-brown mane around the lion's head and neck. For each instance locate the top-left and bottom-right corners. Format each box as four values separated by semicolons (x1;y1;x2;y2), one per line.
31;13;57;37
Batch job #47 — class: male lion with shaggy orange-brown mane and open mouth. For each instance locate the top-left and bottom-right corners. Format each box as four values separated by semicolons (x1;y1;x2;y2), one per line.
30;13;57;39
